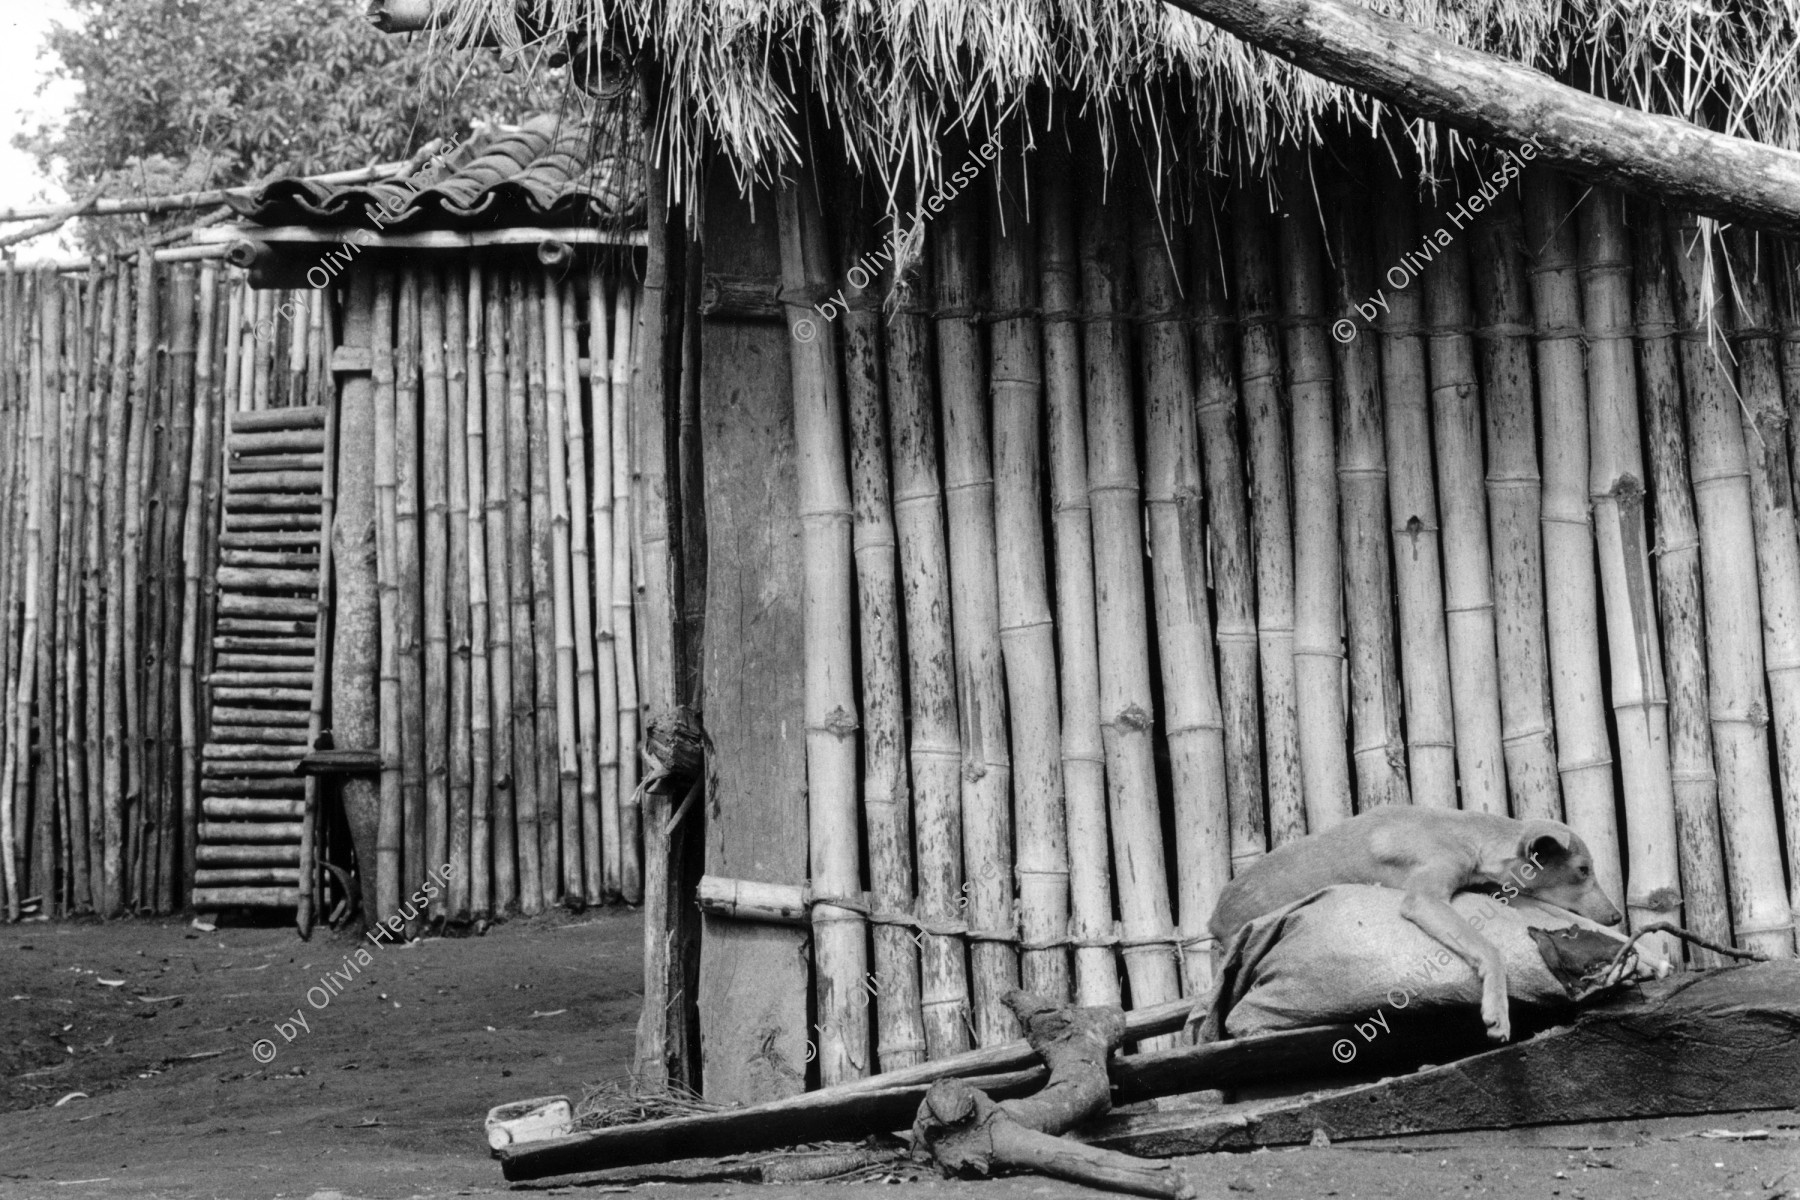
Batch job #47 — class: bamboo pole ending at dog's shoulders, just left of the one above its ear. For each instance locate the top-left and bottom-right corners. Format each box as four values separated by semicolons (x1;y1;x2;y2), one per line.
1425;221;1507;815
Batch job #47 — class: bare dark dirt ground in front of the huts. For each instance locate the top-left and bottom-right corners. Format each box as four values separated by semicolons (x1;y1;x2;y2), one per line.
0;914;1800;1200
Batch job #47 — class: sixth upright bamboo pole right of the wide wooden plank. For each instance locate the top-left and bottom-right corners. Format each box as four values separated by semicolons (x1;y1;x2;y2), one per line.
1044;142;1108;1006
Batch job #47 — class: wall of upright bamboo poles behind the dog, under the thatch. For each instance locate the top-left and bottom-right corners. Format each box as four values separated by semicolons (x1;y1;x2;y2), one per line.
698;146;1800;1099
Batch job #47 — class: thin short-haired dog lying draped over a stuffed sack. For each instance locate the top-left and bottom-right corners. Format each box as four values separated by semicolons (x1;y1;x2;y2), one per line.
1210;806;1622;1042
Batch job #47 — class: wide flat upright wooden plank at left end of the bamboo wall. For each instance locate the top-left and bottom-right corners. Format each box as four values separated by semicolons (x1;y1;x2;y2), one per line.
698;180;812;1103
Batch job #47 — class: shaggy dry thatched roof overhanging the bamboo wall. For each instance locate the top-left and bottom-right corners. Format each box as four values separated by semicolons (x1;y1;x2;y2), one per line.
414;0;1800;206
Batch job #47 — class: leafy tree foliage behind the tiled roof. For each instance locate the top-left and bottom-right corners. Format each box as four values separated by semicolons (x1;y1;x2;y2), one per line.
14;0;562;250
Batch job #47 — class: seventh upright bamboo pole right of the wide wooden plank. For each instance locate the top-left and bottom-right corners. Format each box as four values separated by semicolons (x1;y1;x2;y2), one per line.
1078;144;1181;1021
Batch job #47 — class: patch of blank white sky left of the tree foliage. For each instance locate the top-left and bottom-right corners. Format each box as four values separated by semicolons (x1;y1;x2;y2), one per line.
0;0;74;263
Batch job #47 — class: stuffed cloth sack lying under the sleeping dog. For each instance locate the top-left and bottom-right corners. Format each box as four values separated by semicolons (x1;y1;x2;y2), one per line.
1195;883;1669;1042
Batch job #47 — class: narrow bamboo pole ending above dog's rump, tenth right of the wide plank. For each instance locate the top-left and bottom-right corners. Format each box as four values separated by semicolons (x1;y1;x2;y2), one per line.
1231;187;1307;849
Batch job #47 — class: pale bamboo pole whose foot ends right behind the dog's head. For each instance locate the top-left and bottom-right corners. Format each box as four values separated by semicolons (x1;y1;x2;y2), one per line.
1525;167;1624;896
